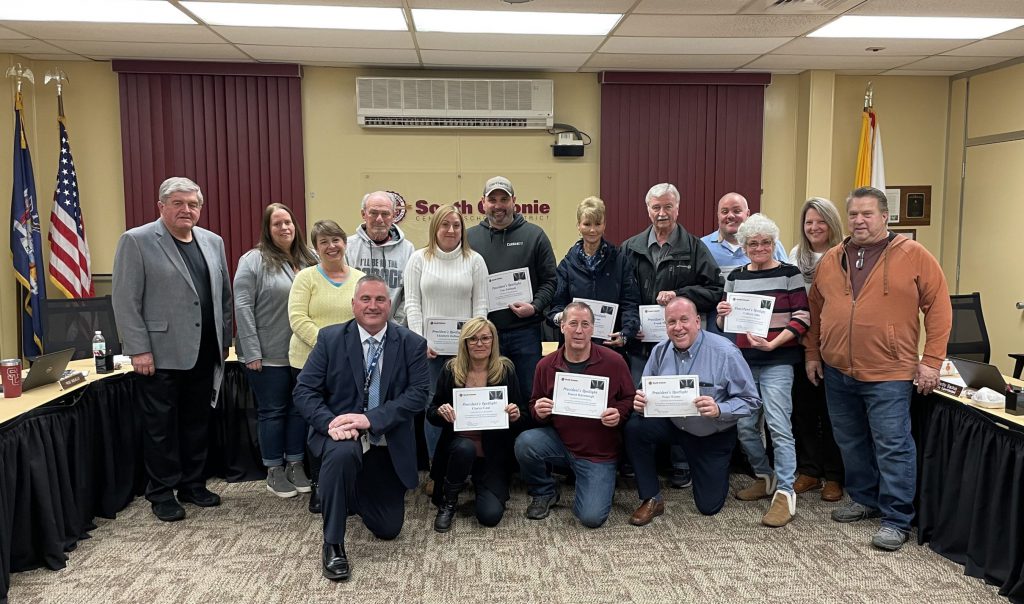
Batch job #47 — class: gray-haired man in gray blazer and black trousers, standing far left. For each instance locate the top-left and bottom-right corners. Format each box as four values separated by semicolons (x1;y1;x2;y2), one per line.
114;177;231;521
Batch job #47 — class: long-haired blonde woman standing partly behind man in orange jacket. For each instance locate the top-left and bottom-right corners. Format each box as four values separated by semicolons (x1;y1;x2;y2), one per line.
790;198;844;502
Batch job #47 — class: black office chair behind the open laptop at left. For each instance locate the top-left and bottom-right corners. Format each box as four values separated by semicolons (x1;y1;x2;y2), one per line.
43;296;121;359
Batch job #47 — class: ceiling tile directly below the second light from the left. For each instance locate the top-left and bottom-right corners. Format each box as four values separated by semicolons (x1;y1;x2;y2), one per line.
212;27;414;48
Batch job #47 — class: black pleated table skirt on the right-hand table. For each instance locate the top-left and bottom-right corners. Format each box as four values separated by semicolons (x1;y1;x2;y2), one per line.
912;395;1024;604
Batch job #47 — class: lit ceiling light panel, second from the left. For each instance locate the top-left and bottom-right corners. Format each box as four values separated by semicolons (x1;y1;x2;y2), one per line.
181;2;409;32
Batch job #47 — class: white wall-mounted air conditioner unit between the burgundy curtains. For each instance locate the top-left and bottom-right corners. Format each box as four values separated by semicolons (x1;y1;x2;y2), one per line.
355;78;555;130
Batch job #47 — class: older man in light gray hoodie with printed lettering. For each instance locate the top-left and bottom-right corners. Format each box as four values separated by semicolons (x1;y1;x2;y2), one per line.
345;190;416;326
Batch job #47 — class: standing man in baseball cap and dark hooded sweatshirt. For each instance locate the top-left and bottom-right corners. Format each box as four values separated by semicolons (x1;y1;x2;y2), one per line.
466;176;557;403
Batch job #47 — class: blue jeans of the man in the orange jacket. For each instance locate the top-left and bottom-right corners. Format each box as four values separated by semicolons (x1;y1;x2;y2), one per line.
824;365;918;531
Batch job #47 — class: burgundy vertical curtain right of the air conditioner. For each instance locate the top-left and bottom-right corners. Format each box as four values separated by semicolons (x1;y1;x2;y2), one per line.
600;72;771;242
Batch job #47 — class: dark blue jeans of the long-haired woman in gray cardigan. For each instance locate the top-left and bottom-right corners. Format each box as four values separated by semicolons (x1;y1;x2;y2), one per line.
246;365;306;468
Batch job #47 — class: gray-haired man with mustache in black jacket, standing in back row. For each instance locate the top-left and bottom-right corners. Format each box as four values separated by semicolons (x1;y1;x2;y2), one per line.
623;182;723;488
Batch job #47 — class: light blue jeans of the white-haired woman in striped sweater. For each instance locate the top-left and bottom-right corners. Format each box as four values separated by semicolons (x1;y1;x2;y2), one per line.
736;364;797;492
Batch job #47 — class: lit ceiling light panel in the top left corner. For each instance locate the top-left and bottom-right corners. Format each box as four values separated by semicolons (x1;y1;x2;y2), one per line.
0;0;196;25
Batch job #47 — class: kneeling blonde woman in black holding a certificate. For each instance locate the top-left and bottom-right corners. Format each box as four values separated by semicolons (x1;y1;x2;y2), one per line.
427;317;525;532
